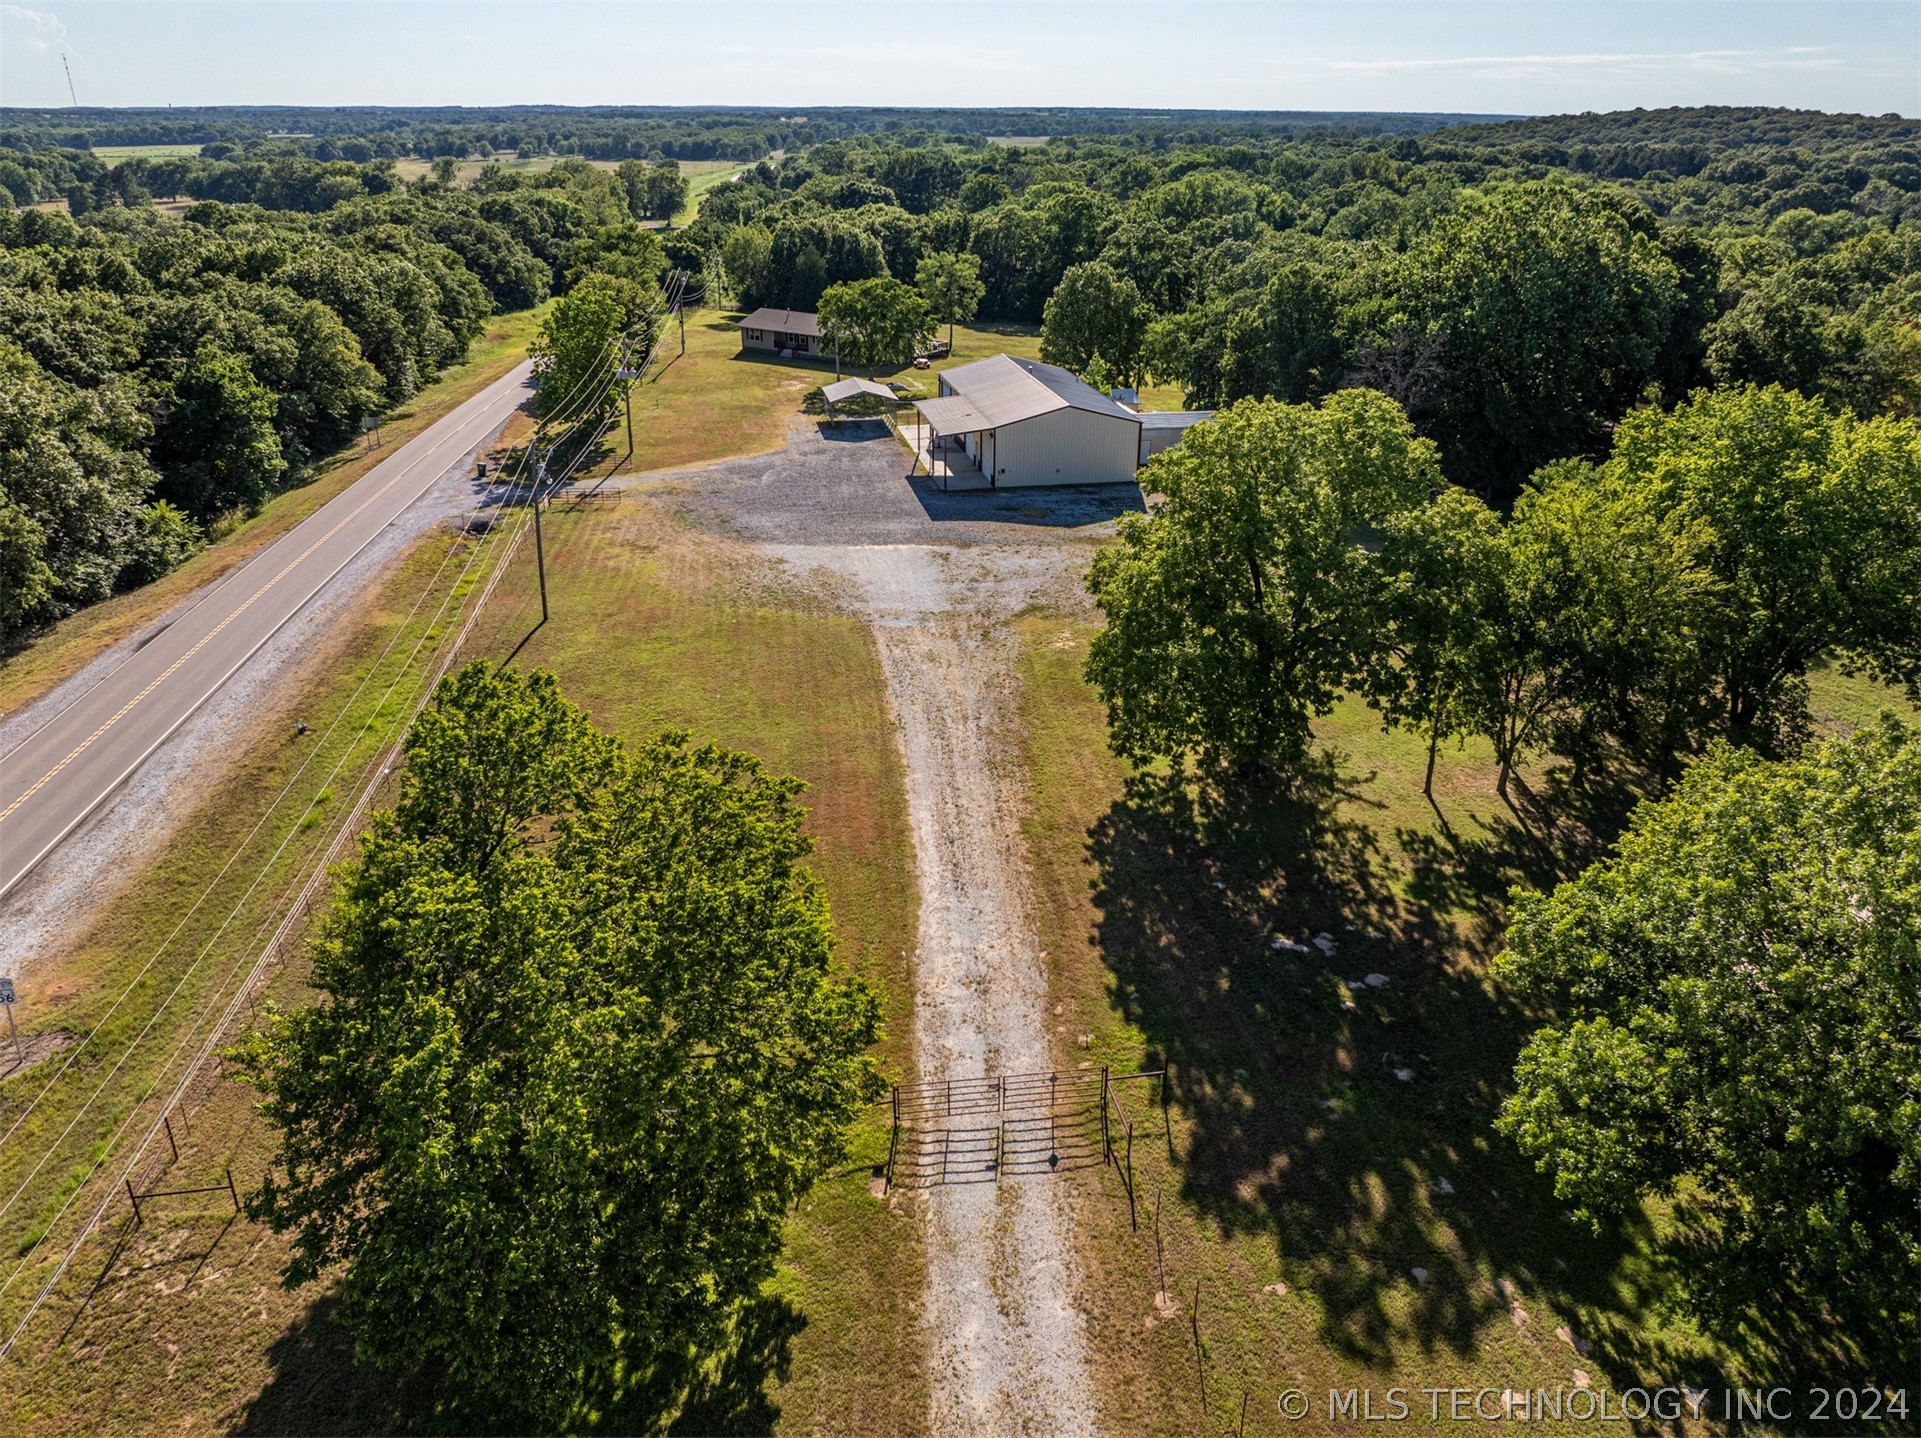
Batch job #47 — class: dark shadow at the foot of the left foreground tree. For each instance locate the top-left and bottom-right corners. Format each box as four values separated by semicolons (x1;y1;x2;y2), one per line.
234;1294;807;1438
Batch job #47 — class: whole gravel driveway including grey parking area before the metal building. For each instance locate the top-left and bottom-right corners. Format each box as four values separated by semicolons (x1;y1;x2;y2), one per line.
622;422;1141;1438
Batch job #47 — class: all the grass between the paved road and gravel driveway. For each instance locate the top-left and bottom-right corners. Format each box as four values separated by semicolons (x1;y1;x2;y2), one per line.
0;501;926;1434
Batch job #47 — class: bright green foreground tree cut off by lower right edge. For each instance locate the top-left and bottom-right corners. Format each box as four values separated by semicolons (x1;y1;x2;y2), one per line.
1496;718;1921;1371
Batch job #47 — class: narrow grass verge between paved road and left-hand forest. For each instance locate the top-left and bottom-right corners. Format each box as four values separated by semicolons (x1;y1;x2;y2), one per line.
0;309;540;714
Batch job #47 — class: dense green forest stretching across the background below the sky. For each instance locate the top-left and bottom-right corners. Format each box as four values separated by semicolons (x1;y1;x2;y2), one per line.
0;109;1921;635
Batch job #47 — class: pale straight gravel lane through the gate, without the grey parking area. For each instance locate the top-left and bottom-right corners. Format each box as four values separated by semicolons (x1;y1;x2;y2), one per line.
772;545;1095;1434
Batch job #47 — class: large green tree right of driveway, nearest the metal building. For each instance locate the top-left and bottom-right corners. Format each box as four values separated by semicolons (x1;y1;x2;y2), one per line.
1087;390;1441;766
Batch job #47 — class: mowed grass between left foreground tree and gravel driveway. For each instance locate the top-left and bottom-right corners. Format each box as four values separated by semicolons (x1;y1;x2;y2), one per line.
451;495;926;1432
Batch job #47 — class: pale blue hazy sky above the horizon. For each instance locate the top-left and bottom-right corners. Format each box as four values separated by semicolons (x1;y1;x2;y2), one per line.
0;0;1921;115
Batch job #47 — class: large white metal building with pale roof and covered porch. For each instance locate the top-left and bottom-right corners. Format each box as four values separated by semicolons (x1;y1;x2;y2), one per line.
914;355;1143;490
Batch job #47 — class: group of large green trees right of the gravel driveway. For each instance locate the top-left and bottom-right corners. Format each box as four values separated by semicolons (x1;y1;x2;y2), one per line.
1085;386;1921;1357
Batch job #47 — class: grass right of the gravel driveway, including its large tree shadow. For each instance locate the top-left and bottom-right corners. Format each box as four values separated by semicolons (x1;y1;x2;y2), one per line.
1022;614;1913;1434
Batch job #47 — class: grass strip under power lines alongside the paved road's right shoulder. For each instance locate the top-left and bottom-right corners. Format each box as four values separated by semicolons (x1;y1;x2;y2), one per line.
0;536;510;1438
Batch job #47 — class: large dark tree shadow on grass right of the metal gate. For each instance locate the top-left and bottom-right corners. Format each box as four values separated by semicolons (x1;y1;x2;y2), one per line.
1089;753;1898;1405
